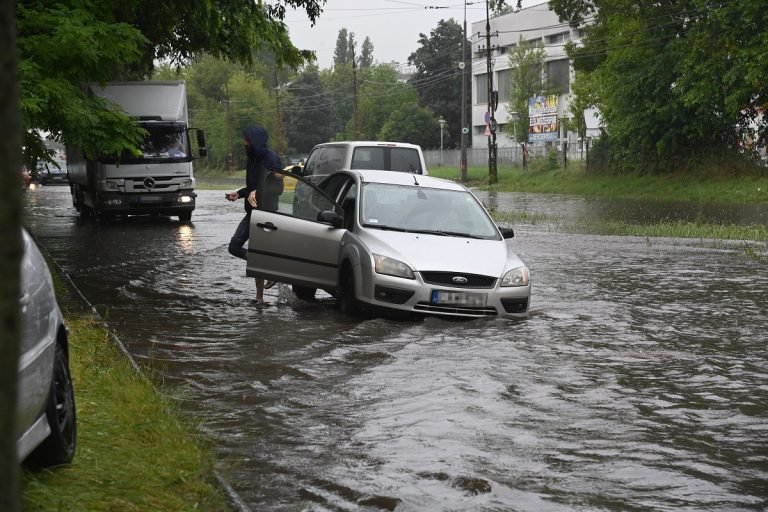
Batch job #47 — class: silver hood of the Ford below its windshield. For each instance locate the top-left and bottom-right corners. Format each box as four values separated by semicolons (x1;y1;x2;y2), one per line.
363;229;523;276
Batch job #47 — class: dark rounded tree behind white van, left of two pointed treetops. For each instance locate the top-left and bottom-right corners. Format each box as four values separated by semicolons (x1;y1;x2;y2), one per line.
284;65;332;153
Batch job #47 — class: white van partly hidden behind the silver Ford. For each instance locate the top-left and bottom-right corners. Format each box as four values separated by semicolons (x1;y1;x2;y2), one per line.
293;141;428;183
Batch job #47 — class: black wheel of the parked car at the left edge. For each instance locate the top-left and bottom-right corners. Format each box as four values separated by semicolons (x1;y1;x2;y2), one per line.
27;343;77;468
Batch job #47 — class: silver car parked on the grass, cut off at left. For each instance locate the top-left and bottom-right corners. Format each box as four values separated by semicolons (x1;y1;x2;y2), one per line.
16;231;77;467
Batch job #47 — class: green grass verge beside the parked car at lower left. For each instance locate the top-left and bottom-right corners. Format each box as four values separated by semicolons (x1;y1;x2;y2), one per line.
22;265;229;512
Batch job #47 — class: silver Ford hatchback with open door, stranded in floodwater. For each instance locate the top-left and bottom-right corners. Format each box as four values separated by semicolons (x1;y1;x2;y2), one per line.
246;170;531;317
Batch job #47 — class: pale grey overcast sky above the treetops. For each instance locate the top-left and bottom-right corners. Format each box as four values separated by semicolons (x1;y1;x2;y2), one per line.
285;0;545;69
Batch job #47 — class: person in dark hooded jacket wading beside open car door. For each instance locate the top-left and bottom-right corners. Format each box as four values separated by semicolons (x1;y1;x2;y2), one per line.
226;125;283;302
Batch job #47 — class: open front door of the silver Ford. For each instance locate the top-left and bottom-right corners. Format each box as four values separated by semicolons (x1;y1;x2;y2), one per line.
246;171;346;289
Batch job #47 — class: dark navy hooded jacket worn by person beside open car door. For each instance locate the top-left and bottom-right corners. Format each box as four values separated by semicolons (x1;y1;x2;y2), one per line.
237;125;283;212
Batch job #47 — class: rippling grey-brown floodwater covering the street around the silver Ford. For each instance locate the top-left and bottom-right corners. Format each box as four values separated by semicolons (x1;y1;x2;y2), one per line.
21;187;768;511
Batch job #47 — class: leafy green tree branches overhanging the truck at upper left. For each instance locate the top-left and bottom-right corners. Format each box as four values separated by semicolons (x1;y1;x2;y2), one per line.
16;0;323;171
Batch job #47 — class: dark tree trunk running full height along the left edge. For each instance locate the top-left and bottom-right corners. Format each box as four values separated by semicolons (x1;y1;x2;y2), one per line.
0;0;22;512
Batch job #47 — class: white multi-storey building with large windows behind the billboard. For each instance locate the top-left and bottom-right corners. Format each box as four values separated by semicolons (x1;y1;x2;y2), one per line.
467;3;596;148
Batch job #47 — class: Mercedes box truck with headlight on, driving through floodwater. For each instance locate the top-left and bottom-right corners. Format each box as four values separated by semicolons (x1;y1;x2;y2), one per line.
67;81;206;222
